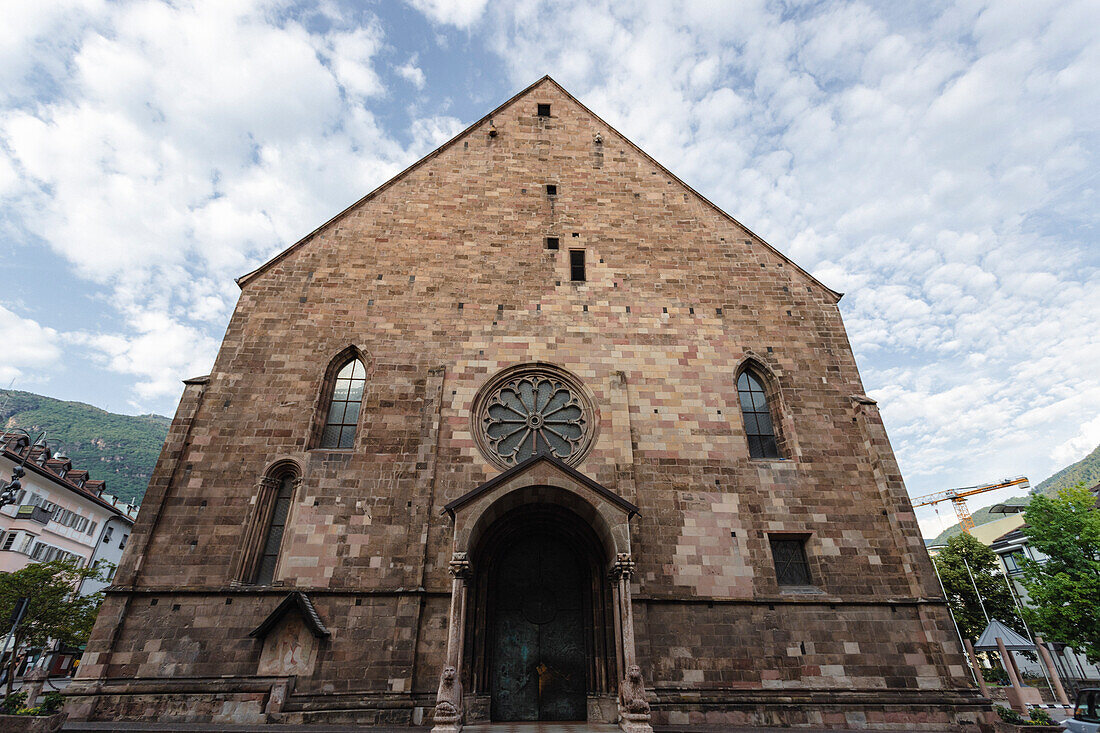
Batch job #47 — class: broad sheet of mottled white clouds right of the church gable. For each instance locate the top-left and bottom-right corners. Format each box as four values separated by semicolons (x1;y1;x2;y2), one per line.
486;1;1100;493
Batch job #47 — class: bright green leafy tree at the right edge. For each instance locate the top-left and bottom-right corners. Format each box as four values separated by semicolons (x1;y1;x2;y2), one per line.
1023;485;1100;664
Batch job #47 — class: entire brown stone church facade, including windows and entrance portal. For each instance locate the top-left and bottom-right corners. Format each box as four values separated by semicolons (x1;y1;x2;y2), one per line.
67;77;989;731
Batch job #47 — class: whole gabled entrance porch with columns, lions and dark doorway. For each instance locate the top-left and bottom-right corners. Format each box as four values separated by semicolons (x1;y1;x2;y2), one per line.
432;455;652;733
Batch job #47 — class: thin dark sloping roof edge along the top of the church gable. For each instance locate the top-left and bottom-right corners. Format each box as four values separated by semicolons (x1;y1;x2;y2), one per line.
229;75;843;302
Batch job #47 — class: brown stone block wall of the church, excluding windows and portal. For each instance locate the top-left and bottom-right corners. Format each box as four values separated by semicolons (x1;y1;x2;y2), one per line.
74;79;990;724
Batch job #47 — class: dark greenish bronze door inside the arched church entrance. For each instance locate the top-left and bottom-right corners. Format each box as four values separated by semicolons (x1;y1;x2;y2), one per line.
490;534;587;721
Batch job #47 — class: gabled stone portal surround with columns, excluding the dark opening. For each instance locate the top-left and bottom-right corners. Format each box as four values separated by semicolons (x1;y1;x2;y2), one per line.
432;455;652;733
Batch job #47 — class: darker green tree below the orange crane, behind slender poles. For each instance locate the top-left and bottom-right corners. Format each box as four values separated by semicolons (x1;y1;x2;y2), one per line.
932;533;1023;638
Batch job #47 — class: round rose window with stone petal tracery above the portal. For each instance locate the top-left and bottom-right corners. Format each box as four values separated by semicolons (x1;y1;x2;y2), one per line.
471;364;598;468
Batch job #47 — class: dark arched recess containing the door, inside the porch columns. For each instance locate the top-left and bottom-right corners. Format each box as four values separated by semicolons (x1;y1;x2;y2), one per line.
468;504;615;721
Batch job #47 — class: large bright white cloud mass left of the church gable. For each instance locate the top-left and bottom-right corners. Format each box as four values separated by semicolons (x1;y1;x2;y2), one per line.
0;0;459;409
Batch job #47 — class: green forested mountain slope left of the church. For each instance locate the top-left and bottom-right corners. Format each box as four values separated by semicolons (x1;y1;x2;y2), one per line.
0;390;172;503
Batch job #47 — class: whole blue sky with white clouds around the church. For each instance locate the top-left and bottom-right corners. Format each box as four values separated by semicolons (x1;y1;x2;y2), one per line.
0;0;1100;532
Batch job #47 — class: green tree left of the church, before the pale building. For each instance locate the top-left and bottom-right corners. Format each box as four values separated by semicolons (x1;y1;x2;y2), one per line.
0;560;103;693
